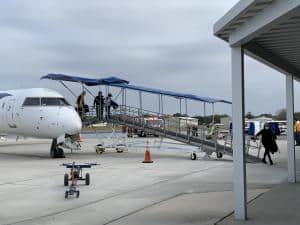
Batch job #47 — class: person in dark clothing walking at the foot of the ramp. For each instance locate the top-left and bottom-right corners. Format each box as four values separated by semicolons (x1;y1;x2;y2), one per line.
255;123;278;165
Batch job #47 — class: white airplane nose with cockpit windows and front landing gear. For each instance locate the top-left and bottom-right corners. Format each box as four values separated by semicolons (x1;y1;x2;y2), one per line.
0;88;82;158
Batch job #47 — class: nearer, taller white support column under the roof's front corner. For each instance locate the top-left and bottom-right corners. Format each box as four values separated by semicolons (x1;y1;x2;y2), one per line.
231;46;247;220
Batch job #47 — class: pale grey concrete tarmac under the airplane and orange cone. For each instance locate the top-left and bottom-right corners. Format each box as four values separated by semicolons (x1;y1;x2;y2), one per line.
0;136;292;225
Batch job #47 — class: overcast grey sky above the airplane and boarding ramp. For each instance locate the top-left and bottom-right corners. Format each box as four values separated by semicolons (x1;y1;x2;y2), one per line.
0;0;300;114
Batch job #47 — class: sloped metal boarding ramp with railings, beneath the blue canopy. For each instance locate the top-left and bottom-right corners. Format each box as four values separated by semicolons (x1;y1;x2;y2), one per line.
107;105;260;162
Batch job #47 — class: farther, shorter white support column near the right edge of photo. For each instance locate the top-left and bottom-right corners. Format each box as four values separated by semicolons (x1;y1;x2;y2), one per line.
286;75;296;183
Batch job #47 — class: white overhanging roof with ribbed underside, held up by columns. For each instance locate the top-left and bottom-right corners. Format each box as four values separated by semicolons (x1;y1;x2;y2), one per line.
214;0;300;80
